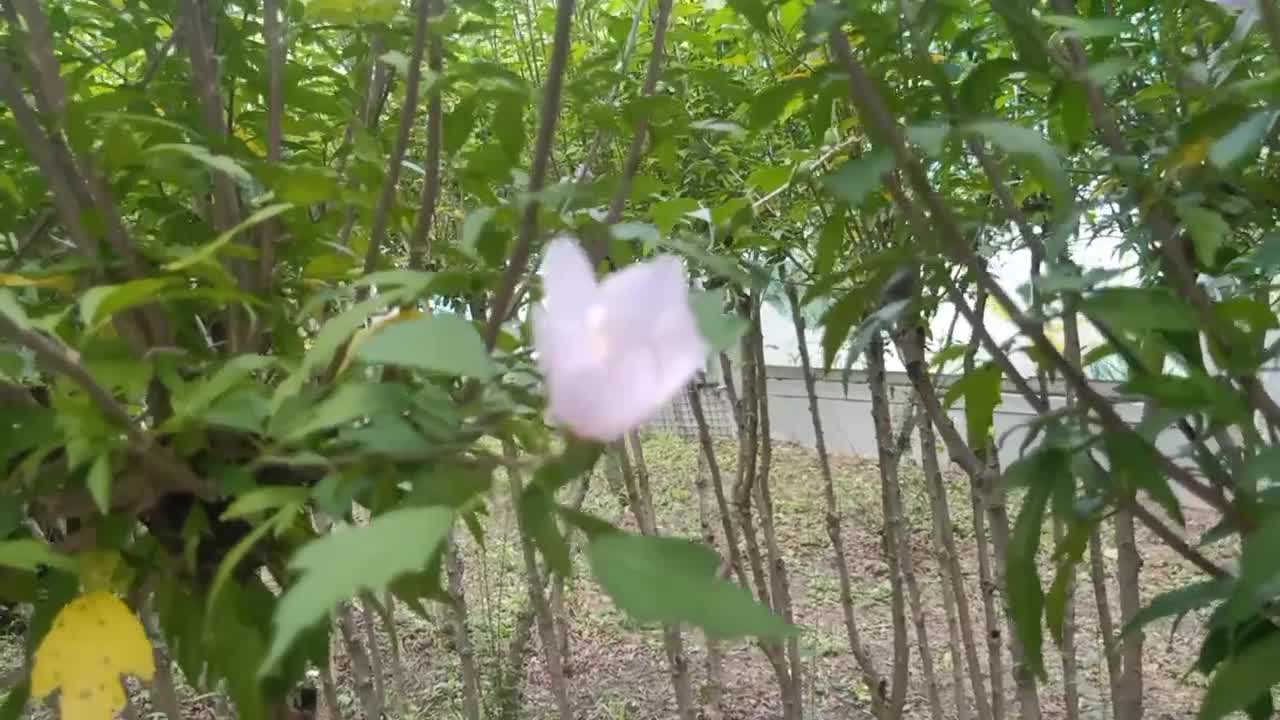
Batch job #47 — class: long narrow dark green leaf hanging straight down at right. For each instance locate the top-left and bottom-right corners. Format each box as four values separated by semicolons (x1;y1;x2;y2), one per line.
1005;448;1068;676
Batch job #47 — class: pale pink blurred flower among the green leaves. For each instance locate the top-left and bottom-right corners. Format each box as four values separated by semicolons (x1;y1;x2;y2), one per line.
534;238;708;442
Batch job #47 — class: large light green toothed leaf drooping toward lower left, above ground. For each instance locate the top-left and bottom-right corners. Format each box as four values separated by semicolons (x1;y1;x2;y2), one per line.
259;507;453;675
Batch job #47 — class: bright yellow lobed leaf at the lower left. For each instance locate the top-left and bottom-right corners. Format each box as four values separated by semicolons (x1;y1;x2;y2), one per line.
31;591;156;720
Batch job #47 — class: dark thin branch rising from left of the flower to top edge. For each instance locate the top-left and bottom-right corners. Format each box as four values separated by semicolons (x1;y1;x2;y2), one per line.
485;0;573;350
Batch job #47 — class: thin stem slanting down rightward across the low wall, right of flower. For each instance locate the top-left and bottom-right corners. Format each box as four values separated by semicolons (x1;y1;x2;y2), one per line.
778;284;890;720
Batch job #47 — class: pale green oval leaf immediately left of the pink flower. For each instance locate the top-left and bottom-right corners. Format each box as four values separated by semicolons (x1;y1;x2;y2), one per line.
356;313;497;379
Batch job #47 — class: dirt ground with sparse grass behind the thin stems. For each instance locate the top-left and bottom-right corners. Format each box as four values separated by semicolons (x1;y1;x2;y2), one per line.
0;436;1226;720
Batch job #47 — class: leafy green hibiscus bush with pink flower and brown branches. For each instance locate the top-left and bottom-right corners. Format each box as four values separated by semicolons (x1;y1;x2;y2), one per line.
0;0;1280;720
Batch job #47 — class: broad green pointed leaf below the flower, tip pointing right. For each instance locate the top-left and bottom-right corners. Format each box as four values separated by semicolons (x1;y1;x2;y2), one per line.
588;533;795;638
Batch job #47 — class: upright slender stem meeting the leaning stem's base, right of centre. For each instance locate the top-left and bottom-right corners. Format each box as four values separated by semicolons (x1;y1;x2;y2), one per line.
867;333;910;717
